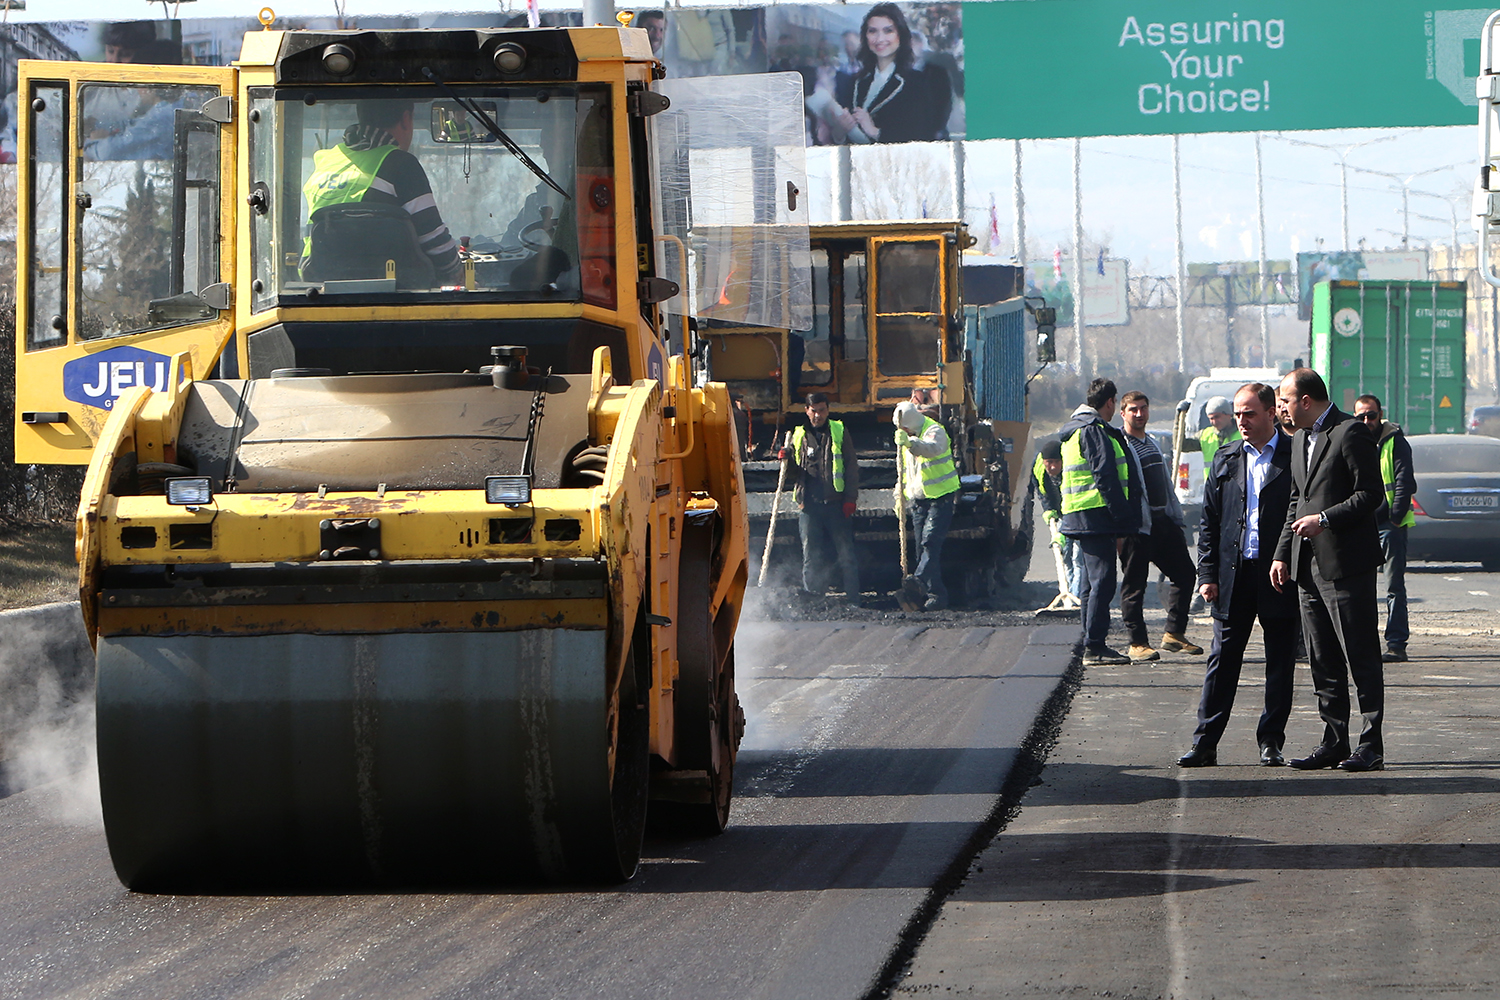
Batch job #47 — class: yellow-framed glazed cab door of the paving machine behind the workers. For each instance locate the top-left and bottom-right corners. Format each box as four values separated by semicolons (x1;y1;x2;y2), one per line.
869;234;962;400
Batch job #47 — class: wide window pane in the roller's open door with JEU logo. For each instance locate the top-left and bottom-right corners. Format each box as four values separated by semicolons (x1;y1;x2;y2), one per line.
75;84;219;339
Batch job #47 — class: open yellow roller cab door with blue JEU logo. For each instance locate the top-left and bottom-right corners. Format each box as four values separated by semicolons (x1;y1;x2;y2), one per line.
15;60;236;465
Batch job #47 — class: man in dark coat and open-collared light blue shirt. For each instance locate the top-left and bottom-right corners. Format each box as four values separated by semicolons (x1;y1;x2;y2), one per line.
1178;382;1298;768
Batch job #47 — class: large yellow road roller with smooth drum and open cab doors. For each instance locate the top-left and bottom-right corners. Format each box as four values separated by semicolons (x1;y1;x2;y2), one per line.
17;10;807;891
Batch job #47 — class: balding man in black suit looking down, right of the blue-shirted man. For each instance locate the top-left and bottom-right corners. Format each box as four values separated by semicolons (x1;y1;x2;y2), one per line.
1271;369;1385;771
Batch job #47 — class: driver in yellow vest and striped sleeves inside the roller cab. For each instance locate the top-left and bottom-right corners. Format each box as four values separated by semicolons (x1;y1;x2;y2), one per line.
302;97;464;285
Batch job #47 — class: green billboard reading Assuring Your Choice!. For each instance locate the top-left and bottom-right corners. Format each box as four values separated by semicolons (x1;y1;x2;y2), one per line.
963;0;1491;139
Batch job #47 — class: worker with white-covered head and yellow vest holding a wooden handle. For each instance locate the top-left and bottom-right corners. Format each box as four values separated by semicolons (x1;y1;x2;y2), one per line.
891;400;959;612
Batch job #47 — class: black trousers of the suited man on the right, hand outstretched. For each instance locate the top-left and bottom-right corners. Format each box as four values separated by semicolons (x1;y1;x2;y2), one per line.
1298;546;1386;754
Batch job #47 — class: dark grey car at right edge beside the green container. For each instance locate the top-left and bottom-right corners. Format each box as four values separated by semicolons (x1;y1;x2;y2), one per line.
1407;435;1500;571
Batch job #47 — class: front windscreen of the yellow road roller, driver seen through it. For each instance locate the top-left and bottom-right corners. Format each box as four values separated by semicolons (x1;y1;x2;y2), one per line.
251;85;615;306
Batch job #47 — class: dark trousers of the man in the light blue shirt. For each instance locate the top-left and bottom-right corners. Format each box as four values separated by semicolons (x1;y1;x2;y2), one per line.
1193;559;1298;750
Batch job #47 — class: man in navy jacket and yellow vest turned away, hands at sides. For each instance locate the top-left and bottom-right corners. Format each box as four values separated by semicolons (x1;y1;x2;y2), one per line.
1062;378;1142;666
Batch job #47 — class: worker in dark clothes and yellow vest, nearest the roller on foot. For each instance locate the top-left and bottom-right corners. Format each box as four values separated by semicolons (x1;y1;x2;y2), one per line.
782;393;860;607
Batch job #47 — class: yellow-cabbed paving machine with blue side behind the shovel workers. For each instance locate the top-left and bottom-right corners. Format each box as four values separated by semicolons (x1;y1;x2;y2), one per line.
701;220;1031;604
